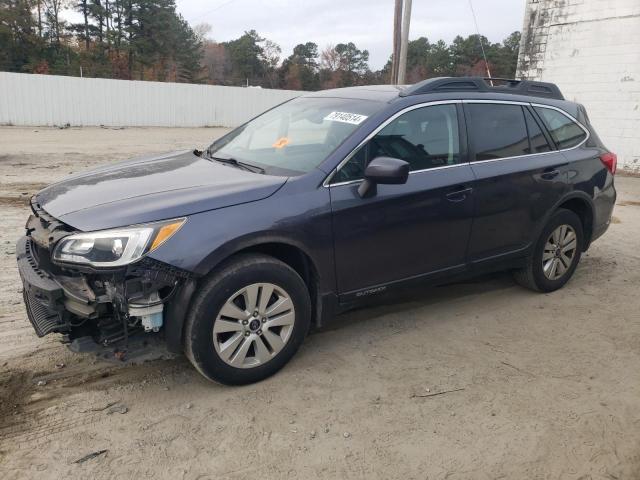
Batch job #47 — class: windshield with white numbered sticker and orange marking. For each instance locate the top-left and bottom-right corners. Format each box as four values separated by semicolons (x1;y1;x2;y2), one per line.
207;98;384;175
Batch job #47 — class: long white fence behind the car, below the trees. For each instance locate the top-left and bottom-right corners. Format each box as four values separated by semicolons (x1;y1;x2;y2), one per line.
0;72;301;127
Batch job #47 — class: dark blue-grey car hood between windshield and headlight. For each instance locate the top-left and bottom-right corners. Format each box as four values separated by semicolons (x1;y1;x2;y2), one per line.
35;151;287;231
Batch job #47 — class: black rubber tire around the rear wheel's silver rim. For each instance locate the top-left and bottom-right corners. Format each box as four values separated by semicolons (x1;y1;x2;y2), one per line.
513;208;584;292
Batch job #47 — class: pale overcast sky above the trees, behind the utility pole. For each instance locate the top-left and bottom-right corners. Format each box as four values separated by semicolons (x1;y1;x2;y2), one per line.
177;0;525;70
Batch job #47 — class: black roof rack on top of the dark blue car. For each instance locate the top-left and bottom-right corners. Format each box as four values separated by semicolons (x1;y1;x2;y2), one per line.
400;77;564;100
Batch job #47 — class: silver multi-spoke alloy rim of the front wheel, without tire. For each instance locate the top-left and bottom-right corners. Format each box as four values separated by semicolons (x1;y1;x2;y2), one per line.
213;283;295;368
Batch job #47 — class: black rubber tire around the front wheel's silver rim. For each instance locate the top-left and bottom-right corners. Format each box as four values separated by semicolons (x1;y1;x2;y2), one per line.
184;254;311;385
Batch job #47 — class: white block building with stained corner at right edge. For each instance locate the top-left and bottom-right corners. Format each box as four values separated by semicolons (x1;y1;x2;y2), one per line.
517;0;640;172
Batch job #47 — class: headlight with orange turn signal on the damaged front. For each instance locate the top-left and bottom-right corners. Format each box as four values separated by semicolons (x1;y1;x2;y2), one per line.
53;218;186;267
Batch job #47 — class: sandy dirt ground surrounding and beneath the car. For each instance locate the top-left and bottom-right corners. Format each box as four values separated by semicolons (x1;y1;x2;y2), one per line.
0;128;640;480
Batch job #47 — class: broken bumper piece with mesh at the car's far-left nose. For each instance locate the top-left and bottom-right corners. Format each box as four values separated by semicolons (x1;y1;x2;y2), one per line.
16;237;69;337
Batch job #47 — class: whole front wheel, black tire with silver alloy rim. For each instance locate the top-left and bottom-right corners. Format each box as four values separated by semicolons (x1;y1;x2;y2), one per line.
185;255;311;385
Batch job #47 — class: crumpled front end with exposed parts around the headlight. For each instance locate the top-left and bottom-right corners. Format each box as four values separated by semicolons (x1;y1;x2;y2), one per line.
16;198;191;360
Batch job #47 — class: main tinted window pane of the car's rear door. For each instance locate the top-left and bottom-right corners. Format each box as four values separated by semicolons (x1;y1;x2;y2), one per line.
465;103;530;161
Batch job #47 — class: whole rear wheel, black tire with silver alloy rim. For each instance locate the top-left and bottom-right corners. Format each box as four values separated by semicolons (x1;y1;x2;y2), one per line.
514;209;584;292
